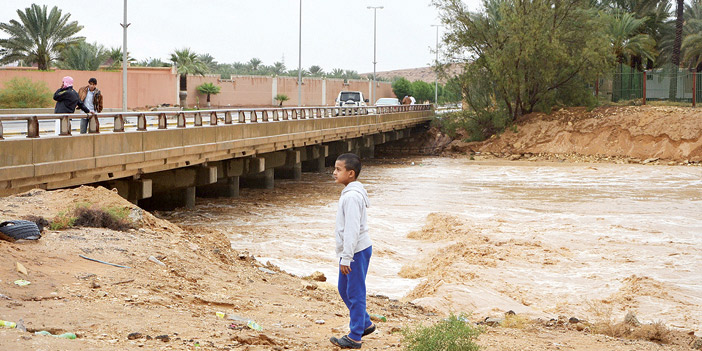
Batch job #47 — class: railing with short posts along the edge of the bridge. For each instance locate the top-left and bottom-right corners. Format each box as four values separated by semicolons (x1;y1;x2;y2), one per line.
0;105;432;140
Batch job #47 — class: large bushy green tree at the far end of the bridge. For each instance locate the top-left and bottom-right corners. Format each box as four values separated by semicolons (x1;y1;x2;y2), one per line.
433;0;611;122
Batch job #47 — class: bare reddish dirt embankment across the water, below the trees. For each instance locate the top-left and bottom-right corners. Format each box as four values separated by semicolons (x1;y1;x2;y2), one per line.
446;106;702;164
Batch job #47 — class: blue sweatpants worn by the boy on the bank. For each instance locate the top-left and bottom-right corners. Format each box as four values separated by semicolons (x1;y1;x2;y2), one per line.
339;246;373;340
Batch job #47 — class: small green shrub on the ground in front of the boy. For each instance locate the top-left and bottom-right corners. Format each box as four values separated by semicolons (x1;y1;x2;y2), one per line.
402;314;482;351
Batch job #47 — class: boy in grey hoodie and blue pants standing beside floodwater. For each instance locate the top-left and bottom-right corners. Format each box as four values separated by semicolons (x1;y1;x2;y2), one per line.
330;153;375;349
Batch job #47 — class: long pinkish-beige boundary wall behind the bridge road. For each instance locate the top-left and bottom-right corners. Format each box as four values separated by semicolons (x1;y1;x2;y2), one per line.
0;67;395;109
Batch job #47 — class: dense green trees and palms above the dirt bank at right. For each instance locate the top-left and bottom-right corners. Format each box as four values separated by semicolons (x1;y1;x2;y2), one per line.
432;0;702;140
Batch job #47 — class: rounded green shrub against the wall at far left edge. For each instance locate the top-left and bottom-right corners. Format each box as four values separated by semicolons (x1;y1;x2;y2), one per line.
0;77;53;108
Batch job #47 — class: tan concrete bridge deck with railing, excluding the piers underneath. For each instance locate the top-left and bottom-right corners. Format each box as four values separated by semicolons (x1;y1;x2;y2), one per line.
0;105;433;196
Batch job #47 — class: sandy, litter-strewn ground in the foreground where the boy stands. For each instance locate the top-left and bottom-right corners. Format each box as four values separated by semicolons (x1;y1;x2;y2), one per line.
0;187;694;351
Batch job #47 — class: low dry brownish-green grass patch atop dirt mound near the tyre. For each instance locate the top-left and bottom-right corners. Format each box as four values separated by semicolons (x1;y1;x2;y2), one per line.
49;203;134;231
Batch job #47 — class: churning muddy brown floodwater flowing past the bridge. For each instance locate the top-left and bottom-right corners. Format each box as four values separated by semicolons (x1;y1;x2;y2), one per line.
165;158;702;331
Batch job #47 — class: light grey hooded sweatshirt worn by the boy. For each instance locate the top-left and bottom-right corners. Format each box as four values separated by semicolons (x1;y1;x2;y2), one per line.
335;181;372;266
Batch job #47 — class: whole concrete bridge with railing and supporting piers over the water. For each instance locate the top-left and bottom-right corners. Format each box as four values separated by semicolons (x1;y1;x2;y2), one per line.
0;105;434;208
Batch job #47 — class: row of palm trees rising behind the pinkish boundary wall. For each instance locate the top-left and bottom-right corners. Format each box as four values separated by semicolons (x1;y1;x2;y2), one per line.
0;4;380;80
